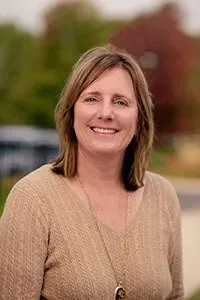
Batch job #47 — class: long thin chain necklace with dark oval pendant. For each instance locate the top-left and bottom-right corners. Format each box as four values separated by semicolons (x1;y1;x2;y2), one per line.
77;176;131;300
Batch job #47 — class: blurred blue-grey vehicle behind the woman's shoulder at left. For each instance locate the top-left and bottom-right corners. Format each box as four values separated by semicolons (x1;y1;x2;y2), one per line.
0;126;58;177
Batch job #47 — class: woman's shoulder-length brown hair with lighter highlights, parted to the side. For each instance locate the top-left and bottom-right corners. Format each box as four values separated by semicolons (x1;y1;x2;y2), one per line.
52;45;154;190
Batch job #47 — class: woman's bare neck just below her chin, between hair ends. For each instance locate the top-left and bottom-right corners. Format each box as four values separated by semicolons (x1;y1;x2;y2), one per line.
78;148;123;191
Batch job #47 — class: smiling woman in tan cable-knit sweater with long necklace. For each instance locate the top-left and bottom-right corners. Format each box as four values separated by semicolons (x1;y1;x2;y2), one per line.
0;47;183;300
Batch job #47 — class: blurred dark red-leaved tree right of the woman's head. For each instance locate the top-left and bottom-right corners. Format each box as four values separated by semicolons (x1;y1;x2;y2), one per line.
111;4;195;133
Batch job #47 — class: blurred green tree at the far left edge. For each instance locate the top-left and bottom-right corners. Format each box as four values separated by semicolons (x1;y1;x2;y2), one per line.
0;24;37;124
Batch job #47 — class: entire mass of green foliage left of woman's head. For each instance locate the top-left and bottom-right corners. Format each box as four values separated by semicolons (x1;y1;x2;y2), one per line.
0;1;119;127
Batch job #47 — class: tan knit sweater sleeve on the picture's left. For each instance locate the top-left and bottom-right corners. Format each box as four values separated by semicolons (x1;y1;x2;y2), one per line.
0;182;48;300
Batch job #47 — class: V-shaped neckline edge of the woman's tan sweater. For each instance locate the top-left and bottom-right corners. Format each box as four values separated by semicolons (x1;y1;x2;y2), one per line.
60;173;149;237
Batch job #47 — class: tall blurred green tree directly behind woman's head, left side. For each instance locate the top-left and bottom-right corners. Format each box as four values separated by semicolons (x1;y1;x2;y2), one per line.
36;1;118;127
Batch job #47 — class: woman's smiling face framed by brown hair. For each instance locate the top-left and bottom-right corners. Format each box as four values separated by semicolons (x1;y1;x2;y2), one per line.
74;67;138;154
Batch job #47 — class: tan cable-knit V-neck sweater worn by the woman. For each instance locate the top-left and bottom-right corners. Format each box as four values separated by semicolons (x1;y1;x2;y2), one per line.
0;165;183;300
